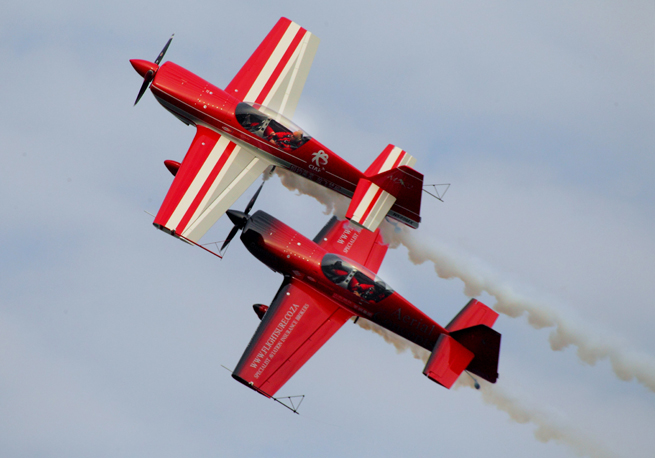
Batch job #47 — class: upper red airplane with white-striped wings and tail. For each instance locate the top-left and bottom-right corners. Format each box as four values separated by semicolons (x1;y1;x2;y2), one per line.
130;18;423;250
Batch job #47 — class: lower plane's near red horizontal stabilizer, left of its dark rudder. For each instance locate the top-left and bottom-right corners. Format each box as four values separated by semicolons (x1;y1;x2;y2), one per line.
423;334;474;388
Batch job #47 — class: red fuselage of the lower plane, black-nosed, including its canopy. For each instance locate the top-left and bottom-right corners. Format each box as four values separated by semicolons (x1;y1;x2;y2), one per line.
241;211;447;351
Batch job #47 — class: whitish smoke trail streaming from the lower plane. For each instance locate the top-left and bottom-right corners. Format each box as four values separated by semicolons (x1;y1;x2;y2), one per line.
357;318;615;458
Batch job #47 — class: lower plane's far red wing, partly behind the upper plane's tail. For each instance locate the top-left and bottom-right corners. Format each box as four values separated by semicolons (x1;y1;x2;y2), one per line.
314;217;389;273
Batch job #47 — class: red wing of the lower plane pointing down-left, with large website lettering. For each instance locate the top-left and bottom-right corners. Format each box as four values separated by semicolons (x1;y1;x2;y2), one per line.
232;279;353;397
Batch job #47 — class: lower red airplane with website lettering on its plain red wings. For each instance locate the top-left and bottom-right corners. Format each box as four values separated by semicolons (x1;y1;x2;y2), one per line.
220;187;500;404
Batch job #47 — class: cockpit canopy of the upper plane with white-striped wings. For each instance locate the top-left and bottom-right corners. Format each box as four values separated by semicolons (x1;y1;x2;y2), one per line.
234;102;312;152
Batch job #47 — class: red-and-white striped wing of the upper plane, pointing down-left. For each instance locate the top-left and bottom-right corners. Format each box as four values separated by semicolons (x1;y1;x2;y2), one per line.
153;126;270;243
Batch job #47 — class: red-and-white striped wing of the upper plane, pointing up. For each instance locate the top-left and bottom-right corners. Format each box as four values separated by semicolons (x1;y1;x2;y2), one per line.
225;18;320;118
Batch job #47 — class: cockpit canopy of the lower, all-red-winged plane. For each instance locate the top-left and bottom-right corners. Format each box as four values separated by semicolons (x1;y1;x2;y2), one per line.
321;253;393;302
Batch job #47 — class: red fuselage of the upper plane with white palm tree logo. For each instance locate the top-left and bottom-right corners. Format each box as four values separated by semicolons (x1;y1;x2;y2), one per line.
142;61;363;197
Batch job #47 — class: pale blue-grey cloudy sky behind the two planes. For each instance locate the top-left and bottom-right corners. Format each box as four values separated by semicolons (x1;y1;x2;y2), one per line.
0;0;655;458
